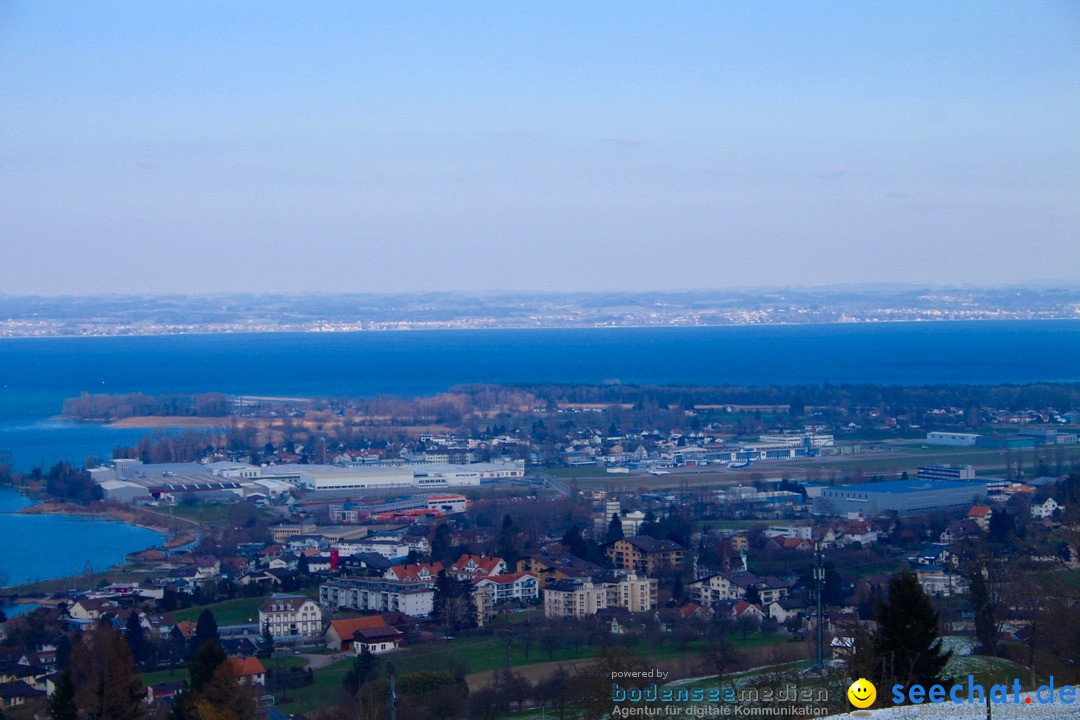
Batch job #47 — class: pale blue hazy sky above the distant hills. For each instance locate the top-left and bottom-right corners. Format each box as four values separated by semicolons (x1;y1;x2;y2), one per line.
0;0;1080;295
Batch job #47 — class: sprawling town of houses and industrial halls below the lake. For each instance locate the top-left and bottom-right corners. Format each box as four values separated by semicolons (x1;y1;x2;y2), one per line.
0;395;1080;718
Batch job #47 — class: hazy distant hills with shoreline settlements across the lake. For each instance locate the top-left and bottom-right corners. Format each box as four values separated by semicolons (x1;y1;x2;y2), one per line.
0;286;1080;337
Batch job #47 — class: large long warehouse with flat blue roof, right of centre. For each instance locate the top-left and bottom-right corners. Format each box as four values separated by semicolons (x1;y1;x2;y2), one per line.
813;480;986;517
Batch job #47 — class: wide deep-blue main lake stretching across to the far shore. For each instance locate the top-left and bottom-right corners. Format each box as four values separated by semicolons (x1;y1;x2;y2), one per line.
0;321;1080;471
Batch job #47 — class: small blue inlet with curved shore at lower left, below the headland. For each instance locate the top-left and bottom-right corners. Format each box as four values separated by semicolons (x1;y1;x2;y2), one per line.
0;488;164;585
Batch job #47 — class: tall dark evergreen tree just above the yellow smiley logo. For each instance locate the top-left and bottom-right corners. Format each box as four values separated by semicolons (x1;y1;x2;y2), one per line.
874;571;953;688
